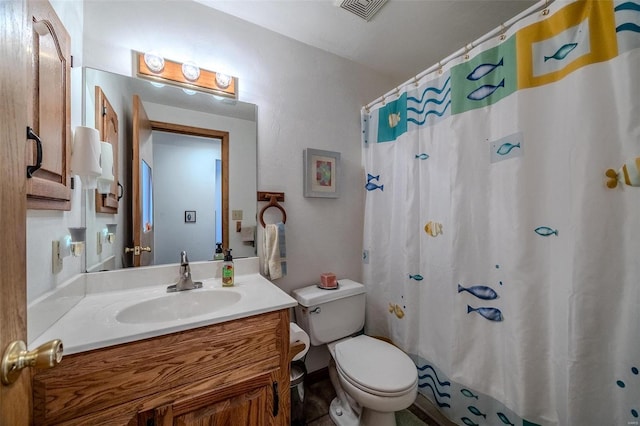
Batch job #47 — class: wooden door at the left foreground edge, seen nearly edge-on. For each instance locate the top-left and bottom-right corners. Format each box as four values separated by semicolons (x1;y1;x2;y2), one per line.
0;1;31;425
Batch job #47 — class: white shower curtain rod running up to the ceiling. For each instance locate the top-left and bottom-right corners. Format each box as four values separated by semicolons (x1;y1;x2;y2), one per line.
363;0;556;112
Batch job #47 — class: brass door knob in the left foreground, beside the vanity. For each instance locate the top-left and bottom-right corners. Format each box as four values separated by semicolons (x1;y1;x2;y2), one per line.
2;339;62;385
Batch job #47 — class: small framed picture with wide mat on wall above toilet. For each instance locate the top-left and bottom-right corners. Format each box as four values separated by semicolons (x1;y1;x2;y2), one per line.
303;148;340;198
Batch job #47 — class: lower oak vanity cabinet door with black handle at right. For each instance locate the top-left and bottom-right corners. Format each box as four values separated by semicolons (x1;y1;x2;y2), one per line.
138;372;279;426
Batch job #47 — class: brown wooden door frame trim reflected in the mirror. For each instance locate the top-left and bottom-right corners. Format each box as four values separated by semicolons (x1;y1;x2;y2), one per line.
151;120;229;248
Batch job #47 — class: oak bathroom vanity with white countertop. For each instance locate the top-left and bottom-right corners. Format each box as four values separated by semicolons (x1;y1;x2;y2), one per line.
25;259;295;426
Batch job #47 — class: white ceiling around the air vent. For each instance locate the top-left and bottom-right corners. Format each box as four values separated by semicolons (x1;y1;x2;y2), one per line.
196;0;536;84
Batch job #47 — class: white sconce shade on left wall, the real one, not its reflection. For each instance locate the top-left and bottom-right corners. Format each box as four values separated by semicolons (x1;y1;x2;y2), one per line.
71;126;102;189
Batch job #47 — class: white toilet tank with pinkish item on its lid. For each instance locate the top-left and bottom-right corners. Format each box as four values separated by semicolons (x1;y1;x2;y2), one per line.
291;279;365;346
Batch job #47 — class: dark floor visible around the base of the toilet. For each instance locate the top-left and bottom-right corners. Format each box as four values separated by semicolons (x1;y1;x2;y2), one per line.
298;370;440;426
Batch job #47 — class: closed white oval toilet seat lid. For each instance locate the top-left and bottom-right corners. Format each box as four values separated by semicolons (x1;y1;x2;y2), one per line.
332;335;418;397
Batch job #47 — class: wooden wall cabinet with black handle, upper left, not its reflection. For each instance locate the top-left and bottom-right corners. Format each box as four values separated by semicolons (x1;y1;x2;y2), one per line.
25;0;72;210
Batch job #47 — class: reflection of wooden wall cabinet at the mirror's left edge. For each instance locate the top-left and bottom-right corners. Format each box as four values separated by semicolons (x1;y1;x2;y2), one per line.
96;86;119;213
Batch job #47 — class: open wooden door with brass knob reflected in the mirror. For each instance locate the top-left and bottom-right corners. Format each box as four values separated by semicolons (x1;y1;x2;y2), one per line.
130;95;153;266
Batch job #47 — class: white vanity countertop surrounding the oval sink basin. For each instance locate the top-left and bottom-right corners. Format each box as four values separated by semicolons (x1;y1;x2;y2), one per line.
29;262;297;355
